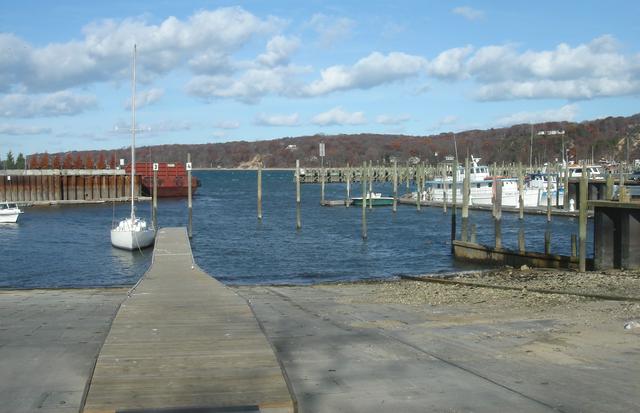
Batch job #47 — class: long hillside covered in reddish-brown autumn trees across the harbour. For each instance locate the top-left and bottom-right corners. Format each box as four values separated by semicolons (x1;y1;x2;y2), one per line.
23;114;640;168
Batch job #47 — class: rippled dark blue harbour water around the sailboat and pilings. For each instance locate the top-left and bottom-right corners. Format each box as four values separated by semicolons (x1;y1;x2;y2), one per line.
0;171;592;288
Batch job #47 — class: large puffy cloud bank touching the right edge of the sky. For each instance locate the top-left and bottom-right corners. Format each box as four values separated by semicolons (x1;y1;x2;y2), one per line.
428;35;640;100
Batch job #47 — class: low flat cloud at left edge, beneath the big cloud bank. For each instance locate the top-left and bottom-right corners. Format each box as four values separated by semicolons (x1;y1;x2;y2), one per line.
0;91;96;118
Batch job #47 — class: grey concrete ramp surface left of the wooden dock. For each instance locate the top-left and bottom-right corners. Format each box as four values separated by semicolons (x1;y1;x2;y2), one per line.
0;289;127;413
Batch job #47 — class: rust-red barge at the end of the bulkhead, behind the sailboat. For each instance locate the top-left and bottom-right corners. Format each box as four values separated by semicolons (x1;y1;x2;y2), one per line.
126;162;200;198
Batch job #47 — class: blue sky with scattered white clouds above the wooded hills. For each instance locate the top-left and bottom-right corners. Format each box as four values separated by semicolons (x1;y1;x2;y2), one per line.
0;0;640;157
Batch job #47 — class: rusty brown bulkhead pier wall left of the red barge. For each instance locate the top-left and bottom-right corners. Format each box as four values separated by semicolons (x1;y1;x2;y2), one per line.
0;169;142;205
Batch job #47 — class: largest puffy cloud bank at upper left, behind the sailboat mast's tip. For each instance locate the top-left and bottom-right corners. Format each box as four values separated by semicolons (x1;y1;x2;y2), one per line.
0;7;284;92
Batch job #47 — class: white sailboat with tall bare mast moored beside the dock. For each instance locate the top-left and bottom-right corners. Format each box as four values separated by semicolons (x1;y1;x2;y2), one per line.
111;45;156;250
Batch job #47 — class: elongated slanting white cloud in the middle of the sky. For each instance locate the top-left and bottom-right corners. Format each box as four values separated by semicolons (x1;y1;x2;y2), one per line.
303;52;427;96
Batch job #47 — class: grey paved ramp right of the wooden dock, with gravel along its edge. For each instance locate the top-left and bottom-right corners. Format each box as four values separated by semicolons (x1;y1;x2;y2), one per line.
237;284;640;412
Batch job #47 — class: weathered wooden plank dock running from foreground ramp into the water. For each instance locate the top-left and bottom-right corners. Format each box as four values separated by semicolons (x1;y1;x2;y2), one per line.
83;228;296;413
